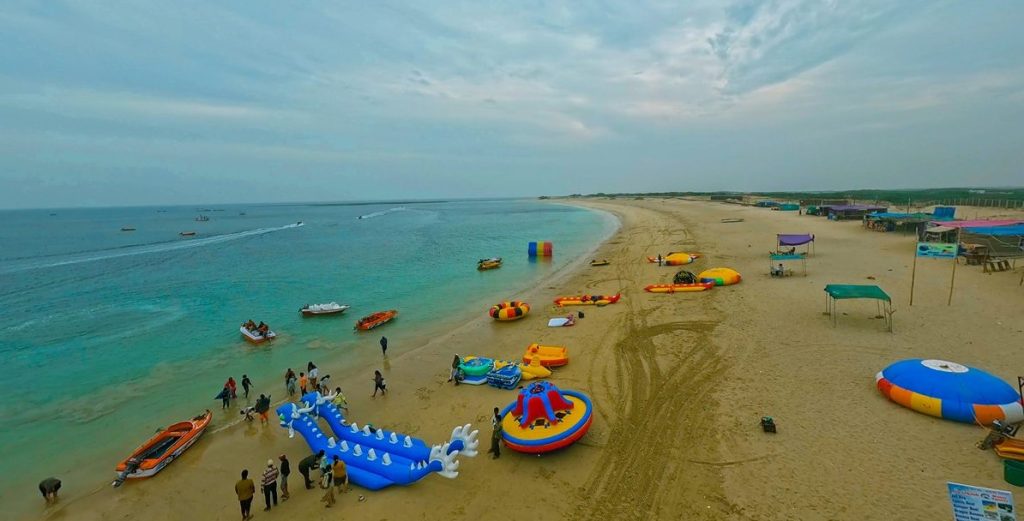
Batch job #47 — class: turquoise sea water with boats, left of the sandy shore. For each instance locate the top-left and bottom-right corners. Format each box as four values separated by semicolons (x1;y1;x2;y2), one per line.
0;200;616;512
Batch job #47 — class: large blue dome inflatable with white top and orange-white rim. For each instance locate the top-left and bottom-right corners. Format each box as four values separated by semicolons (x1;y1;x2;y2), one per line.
874;358;1024;425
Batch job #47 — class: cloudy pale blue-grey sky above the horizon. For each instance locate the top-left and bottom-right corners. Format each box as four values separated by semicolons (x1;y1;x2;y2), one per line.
0;0;1024;208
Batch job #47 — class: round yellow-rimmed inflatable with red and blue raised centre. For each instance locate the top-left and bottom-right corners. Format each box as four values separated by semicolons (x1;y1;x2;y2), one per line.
501;382;594;454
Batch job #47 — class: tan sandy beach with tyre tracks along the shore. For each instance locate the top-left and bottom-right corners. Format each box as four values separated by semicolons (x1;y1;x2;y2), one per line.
37;199;1024;520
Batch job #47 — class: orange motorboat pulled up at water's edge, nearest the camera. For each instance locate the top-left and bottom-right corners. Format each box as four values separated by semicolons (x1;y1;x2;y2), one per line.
112;409;213;486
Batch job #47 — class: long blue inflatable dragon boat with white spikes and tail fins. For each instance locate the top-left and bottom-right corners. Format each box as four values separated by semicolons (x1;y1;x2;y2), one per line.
275;393;479;490
